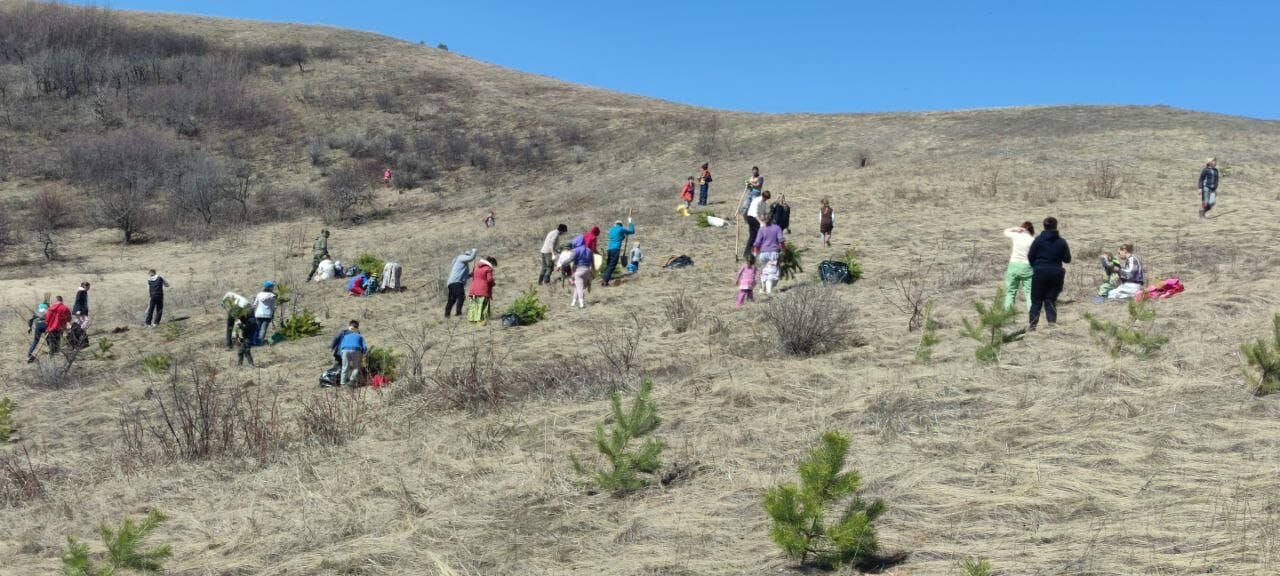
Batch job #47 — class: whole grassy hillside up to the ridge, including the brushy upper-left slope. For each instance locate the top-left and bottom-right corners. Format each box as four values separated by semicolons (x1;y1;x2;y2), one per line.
0;3;1280;576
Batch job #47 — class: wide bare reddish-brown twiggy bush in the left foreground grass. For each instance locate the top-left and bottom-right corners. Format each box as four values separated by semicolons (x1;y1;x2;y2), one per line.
116;361;289;463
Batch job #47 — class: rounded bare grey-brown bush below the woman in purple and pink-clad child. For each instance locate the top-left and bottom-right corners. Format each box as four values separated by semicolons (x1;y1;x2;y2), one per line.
764;285;854;356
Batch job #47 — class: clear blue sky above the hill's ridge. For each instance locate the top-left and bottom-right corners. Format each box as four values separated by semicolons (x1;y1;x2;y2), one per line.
77;0;1280;119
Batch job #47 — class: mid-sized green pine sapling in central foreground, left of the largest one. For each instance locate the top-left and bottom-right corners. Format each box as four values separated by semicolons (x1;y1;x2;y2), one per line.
571;379;666;497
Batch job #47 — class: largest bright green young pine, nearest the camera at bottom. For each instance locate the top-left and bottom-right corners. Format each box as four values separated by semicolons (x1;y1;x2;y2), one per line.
764;431;884;570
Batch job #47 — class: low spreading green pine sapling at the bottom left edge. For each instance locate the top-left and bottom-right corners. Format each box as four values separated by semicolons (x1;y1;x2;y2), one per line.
61;511;173;576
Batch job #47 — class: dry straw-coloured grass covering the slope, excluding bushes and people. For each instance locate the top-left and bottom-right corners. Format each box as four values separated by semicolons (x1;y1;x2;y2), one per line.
0;5;1280;575
